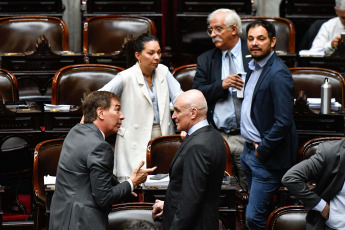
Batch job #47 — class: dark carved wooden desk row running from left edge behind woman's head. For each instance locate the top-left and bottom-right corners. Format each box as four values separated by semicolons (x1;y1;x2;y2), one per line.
0;35;171;103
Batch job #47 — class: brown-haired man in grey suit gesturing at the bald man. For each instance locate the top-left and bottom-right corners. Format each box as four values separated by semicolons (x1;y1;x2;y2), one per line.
49;91;155;230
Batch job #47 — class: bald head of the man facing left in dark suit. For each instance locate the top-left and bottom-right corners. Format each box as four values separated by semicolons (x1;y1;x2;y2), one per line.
172;89;207;132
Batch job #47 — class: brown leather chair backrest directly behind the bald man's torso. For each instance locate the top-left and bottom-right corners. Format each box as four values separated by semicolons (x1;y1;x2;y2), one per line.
146;134;232;175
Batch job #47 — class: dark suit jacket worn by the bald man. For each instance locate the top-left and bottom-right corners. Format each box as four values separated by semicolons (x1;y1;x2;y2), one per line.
163;125;226;230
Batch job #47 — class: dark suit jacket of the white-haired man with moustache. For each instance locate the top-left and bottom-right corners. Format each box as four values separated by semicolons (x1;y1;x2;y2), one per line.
193;40;250;125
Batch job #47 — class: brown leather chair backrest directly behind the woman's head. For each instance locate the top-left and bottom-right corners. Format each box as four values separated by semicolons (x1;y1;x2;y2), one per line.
83;15;156;54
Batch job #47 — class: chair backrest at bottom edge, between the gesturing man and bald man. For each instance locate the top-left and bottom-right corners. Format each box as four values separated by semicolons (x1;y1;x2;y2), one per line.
107;202;162;230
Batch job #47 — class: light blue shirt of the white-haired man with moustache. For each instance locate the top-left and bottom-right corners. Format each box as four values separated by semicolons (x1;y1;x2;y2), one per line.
213;39;244;132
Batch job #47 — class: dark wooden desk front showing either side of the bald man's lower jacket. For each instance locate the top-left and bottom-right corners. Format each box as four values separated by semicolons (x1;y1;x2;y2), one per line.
142;182;240;229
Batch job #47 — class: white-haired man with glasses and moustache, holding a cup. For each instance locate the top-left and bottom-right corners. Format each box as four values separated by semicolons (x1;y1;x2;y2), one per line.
193;9;250;190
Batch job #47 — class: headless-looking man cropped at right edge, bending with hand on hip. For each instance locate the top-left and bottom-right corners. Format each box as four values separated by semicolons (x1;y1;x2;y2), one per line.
282;139;345;230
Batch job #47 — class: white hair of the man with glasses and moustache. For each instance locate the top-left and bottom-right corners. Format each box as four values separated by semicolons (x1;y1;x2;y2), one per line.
207;8;241;35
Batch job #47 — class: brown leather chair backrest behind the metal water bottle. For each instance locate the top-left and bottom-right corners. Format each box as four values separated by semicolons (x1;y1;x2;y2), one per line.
290;67;345;108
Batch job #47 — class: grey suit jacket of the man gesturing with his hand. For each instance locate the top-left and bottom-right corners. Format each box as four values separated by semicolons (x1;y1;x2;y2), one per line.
49;123;131;230
